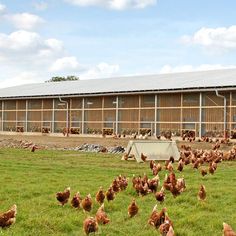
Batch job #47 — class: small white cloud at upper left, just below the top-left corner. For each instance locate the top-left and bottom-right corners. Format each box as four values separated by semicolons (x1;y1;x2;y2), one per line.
5;13;44;30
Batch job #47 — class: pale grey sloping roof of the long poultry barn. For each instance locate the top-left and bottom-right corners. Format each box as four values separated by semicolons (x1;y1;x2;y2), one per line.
0;69;236;98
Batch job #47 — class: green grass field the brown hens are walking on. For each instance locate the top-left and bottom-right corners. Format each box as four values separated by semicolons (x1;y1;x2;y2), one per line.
0;149;236;236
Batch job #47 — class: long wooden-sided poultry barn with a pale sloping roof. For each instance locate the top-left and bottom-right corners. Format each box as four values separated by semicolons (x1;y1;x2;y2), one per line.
0;69;236;137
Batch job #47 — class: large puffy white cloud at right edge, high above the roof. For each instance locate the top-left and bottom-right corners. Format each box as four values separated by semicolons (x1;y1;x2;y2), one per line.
182;25;236;50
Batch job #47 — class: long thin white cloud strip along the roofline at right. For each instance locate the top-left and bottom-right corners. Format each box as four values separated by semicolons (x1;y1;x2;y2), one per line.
159;64;236;74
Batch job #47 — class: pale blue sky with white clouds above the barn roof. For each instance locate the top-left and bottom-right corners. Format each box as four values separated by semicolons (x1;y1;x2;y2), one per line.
0;0;236;88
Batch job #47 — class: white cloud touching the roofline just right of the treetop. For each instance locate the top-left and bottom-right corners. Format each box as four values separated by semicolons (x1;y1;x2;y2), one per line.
79;62;120;79
